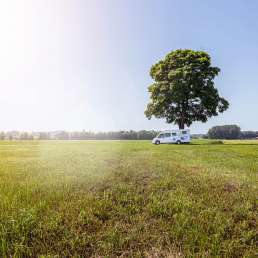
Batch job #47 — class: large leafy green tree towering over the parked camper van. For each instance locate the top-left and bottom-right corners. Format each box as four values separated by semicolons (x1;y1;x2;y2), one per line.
145;49;229;129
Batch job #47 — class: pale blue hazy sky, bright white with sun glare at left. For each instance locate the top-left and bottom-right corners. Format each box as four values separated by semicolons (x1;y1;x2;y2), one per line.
0;0;258;132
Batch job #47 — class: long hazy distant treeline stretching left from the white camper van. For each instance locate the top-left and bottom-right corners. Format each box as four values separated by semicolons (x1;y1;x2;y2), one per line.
0;130;159;140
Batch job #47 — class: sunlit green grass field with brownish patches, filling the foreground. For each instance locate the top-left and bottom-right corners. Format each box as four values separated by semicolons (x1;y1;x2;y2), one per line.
0;141;258;257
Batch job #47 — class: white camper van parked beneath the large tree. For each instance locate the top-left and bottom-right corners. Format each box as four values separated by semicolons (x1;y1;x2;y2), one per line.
152;129;191;145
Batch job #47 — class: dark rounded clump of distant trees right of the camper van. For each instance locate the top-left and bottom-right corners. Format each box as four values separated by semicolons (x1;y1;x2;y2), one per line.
208;125;241;139
